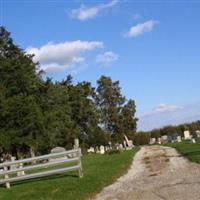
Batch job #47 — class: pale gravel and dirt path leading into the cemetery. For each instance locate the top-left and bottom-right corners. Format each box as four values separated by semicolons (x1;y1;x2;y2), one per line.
95;146;200;200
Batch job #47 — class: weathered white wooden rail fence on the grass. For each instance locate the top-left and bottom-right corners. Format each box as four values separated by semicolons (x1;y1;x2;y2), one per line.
0;148;83;188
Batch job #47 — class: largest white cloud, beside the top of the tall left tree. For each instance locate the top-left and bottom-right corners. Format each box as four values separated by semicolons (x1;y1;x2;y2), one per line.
26;40;103;72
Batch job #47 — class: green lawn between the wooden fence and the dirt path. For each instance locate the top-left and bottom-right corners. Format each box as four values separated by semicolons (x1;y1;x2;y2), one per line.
0;148;139;200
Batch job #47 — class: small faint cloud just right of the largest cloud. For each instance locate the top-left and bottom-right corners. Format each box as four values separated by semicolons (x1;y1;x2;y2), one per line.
96;51;119;64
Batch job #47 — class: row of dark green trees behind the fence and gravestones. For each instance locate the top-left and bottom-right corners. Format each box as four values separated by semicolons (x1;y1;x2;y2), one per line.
0;27;137;158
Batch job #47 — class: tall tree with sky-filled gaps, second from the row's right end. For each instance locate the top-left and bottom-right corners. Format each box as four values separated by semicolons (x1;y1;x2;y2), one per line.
96;76;125;141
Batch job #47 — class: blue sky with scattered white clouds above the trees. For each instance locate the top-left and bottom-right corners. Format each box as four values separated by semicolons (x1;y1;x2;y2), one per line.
0;0;200;130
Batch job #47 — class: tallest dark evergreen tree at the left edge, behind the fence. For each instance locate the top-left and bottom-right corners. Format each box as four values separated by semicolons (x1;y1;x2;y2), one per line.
0;27;43;158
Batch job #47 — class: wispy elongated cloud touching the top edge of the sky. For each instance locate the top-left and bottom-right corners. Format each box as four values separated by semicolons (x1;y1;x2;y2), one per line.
69;0;118;21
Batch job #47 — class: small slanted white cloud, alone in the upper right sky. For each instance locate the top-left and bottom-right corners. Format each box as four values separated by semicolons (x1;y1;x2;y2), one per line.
124;20;159;38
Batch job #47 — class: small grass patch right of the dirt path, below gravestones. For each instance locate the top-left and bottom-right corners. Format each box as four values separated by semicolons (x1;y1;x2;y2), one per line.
166;138;200;163
